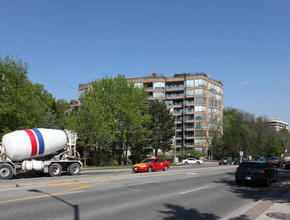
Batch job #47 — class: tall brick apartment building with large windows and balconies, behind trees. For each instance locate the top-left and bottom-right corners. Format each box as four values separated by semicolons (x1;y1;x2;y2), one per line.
128;73;223;156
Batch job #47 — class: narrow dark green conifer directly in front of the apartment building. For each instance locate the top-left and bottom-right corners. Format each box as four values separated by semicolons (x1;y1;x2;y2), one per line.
149;100;174;156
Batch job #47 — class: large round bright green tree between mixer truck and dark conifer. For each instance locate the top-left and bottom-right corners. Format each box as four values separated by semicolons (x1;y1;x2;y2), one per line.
69;75;150;164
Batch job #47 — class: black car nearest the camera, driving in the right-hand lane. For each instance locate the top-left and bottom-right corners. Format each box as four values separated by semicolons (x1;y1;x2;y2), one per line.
235;161;278;186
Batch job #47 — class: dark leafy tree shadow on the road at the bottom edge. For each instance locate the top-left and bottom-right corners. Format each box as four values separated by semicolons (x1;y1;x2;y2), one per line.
159;203;220;220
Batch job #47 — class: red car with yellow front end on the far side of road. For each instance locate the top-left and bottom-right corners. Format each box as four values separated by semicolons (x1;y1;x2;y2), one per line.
132;157;170;173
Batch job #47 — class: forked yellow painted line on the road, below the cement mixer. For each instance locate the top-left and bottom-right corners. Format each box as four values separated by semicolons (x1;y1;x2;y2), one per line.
0;180;106;204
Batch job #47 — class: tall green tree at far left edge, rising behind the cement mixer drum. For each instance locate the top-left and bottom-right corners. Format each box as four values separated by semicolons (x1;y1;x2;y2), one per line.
0;57;47;136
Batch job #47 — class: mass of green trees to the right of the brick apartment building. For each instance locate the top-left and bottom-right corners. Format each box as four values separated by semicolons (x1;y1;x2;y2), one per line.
212;108;290;159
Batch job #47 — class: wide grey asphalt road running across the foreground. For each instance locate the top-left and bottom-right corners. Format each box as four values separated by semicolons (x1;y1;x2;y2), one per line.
0;164;290;220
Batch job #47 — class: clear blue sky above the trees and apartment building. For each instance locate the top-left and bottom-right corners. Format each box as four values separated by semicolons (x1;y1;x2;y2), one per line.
0;0;290;124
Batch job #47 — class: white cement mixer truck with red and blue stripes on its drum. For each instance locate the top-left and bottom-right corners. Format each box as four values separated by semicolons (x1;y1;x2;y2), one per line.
0;128;82;179
